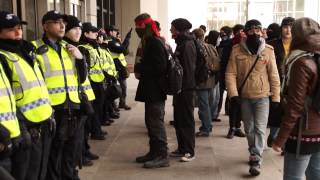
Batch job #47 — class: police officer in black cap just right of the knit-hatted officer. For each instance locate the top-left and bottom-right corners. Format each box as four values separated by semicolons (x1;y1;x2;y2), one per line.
79;22;106;140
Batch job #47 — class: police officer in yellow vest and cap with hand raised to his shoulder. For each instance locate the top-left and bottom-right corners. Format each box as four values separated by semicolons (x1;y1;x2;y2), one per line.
33;11;86;180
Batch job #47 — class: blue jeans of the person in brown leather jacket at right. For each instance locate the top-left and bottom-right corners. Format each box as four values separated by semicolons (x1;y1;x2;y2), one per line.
283;152;320;180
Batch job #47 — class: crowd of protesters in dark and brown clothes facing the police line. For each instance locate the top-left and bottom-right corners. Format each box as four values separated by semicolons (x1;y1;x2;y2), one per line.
135;14;320;180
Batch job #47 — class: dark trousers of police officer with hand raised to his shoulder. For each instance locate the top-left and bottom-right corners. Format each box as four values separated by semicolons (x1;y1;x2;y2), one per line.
46;109;80;180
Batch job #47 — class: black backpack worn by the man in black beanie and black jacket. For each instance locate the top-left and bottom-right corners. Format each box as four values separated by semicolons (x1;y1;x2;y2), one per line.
194;40;211;85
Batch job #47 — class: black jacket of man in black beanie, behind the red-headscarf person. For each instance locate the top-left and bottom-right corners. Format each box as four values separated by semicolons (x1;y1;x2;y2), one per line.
174;33;197;91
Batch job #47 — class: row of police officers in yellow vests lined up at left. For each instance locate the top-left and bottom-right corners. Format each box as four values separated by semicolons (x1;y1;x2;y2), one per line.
0;11;131;180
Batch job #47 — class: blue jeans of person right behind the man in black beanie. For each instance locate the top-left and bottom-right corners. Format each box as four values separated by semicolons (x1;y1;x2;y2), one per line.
197;89;212;133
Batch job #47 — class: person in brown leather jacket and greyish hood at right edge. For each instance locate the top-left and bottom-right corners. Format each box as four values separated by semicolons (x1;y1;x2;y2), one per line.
273;18;320;180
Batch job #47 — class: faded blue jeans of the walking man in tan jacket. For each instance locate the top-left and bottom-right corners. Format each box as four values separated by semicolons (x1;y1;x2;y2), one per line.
241;97;269;162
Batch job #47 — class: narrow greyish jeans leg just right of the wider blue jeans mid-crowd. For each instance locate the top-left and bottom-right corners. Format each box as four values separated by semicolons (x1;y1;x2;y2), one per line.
209;83;220;119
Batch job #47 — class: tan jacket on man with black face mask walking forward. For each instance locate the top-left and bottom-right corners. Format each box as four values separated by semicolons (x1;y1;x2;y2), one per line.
225;39;280;102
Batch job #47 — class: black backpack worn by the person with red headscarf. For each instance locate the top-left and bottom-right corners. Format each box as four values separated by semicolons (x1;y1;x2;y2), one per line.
161;41;183;95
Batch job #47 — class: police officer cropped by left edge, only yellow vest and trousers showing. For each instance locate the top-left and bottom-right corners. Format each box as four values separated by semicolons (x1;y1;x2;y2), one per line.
0;56;20;180
